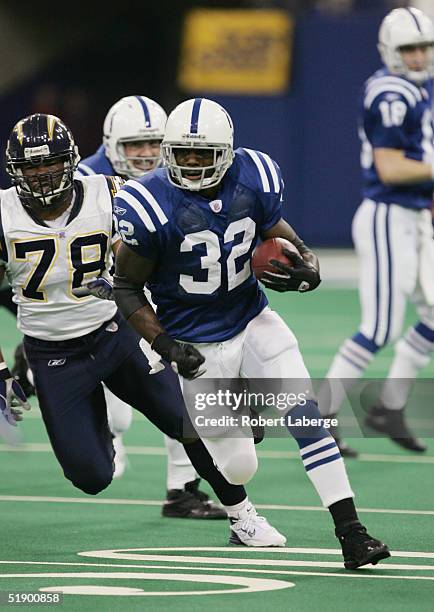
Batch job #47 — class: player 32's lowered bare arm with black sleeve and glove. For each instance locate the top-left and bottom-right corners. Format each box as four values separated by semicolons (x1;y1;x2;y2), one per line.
114;244;205;379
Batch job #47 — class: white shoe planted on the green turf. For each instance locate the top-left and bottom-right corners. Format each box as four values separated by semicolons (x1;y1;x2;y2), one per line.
229;504;286;546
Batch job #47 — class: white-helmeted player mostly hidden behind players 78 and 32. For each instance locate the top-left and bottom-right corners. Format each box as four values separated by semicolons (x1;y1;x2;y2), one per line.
77;96;226;519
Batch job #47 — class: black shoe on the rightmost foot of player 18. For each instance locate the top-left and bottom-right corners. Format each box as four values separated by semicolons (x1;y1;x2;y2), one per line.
365;406;427;453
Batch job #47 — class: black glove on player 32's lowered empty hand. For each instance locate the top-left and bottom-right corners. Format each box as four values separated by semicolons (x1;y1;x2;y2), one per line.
151;333;206;380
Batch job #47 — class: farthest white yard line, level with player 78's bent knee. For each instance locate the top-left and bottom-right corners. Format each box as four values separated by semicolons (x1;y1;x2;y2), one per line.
0;442;434;465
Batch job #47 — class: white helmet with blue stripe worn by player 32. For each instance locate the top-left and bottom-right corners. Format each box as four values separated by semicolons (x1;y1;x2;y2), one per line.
161;98;234;191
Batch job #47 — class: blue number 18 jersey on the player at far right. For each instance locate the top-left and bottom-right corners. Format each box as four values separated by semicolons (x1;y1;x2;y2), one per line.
359;69;434;209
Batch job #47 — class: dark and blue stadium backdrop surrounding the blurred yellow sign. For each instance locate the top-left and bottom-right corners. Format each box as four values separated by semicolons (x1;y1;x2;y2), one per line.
0;0;405;246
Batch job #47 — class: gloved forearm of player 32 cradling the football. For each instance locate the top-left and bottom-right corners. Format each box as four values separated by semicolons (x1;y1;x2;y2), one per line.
261;219;321;292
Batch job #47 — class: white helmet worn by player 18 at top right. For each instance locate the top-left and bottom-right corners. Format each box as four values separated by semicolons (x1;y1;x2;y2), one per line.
378;7;434;84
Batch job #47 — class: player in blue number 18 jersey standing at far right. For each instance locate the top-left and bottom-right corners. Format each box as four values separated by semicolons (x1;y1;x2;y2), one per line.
319;8;434;456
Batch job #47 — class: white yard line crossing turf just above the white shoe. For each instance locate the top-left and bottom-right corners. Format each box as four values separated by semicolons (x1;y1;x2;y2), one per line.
0;495;434;516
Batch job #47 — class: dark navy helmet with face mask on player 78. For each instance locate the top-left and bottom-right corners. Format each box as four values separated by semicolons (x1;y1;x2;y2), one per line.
6;114;80;212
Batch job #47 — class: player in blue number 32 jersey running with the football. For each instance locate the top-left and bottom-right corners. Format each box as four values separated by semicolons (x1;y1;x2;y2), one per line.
109;98;389;568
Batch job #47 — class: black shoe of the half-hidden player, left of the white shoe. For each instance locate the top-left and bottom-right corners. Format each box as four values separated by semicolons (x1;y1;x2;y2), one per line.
162;478;228;520
